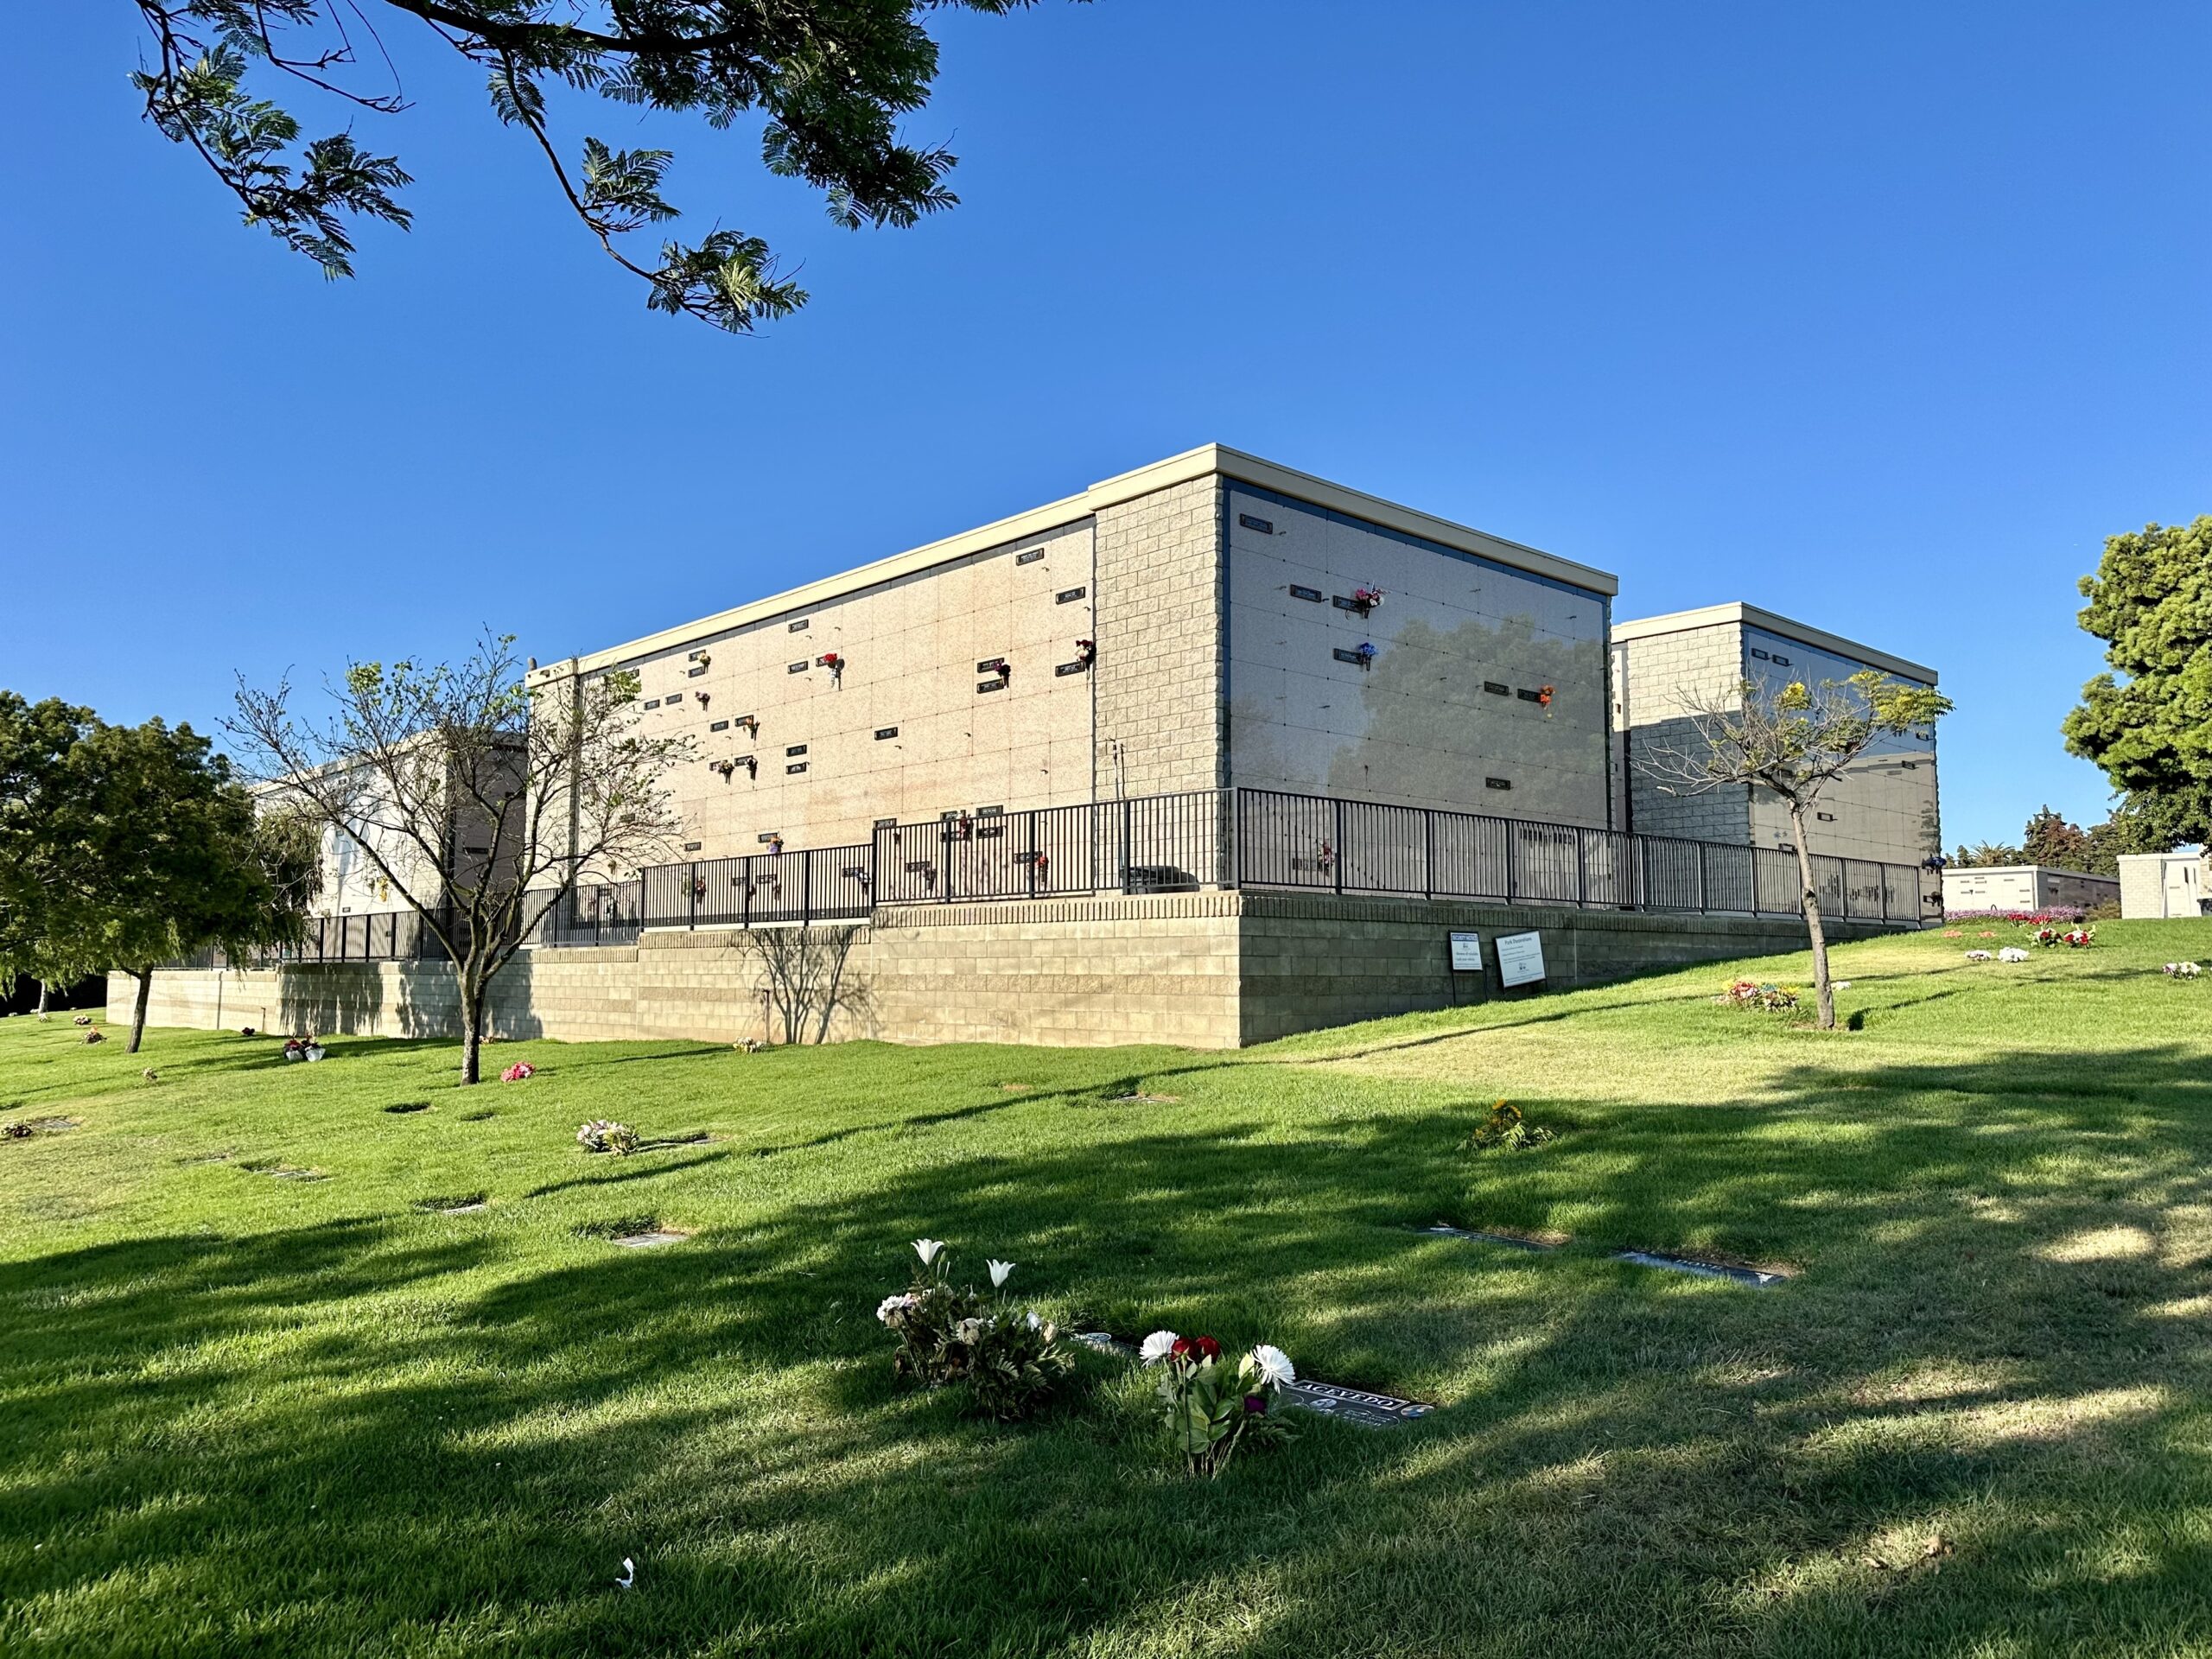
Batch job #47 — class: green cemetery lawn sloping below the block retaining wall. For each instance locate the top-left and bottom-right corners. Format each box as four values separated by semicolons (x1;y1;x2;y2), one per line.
0;923;2212;1659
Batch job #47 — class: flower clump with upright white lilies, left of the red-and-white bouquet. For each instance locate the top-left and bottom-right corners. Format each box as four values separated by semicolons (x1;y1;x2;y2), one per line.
876;1239;1075;1422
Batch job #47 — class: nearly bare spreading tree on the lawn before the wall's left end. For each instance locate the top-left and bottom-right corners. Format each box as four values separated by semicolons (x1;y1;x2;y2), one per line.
230;635;692;1084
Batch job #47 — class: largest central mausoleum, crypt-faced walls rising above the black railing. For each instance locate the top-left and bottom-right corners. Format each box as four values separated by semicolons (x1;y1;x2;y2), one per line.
536;445;1617;875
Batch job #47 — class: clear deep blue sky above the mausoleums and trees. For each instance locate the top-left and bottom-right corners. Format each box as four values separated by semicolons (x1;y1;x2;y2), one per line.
0;0;2212;841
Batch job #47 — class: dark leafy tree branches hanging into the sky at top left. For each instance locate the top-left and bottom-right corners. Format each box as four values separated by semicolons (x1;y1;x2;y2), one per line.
133;0;1061;334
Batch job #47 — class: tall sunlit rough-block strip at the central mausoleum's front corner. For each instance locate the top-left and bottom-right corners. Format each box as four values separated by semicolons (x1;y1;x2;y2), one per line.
1093;475;1228;801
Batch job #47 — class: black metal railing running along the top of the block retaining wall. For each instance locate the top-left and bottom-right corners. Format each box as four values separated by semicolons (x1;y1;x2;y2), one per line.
177;790;1931;967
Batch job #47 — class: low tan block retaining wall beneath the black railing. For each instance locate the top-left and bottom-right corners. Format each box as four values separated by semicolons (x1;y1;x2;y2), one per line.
121;893;1910;1048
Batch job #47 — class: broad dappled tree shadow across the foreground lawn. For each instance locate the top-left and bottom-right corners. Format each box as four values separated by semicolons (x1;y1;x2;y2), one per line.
13;1048;2212;1655
